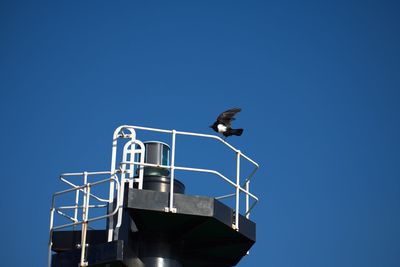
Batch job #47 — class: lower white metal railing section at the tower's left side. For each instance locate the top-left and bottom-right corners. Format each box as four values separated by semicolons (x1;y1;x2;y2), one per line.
48;171;121;267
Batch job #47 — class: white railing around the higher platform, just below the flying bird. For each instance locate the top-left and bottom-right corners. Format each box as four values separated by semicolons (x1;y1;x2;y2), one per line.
109;125;259;232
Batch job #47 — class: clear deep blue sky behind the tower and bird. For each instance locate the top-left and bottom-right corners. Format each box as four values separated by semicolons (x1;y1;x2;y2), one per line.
0;0;400;267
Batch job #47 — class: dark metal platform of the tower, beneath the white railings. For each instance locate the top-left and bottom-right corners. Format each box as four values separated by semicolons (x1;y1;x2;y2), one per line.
53;189;256;267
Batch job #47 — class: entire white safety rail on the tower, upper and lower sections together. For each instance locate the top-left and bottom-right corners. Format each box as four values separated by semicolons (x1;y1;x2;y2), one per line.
48;125;259;267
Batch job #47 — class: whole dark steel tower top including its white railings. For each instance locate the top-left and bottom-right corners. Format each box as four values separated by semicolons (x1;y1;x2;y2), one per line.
48;125;259;267
